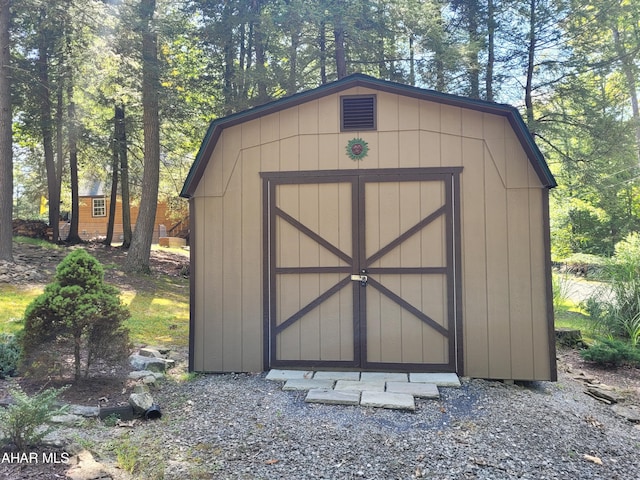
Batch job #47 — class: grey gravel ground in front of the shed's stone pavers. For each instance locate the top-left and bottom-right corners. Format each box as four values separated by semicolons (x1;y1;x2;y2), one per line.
100;366;640;480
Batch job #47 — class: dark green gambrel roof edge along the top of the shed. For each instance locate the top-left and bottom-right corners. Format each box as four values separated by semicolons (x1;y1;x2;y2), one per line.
180;73;557;198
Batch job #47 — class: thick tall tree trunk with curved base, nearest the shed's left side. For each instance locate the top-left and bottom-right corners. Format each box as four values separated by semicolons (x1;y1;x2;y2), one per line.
125;0;160;272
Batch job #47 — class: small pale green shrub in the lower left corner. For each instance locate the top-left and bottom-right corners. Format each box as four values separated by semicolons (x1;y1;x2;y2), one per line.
0;384;68;451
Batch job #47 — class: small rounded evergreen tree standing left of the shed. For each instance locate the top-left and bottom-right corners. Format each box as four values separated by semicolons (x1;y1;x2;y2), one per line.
22;249;129;380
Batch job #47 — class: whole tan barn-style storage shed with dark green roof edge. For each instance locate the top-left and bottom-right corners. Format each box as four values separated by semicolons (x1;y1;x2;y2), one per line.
181;74;556;380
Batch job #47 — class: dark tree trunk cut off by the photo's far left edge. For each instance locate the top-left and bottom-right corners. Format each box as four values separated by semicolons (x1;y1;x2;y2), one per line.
0;0;13;262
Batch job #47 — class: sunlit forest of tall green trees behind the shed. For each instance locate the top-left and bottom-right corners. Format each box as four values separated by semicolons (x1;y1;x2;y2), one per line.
0;0;640;270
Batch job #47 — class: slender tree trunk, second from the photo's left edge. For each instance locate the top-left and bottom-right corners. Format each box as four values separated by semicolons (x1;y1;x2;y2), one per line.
37;11;60;242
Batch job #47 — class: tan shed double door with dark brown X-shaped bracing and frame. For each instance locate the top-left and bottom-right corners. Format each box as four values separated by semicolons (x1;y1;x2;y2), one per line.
263;169;461;372
